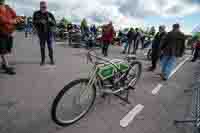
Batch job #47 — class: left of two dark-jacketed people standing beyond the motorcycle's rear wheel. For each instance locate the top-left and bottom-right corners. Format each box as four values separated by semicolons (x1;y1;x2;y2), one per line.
123;28;135;54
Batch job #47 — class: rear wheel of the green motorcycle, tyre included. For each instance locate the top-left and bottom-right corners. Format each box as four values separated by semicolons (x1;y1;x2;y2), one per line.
126;61;142;88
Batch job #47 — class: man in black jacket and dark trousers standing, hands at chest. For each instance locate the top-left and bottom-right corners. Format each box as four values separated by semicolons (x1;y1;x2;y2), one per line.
33;1;56;66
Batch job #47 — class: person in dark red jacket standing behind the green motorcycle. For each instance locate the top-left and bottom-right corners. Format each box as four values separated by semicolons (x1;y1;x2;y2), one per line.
102;22;115;57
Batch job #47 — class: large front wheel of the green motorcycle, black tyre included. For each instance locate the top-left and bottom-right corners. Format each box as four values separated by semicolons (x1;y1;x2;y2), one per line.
51;79;96;126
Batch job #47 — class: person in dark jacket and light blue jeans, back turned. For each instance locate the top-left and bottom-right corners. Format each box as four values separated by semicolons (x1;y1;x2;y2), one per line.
160;24;186;80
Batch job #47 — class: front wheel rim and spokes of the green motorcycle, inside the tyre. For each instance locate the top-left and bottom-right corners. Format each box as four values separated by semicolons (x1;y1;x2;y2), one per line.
56;82;94;124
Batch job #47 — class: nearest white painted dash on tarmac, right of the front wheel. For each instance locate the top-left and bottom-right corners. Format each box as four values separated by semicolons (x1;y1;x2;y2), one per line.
120;104;144;127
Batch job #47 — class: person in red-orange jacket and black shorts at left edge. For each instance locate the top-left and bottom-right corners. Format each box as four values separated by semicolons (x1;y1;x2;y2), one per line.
0;0;23;75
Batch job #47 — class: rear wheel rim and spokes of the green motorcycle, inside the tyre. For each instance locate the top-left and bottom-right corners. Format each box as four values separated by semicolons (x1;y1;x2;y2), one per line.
127;64;140;87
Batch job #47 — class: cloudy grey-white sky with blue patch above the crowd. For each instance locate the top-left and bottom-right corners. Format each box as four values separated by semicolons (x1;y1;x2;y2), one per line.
7;0;200;33
